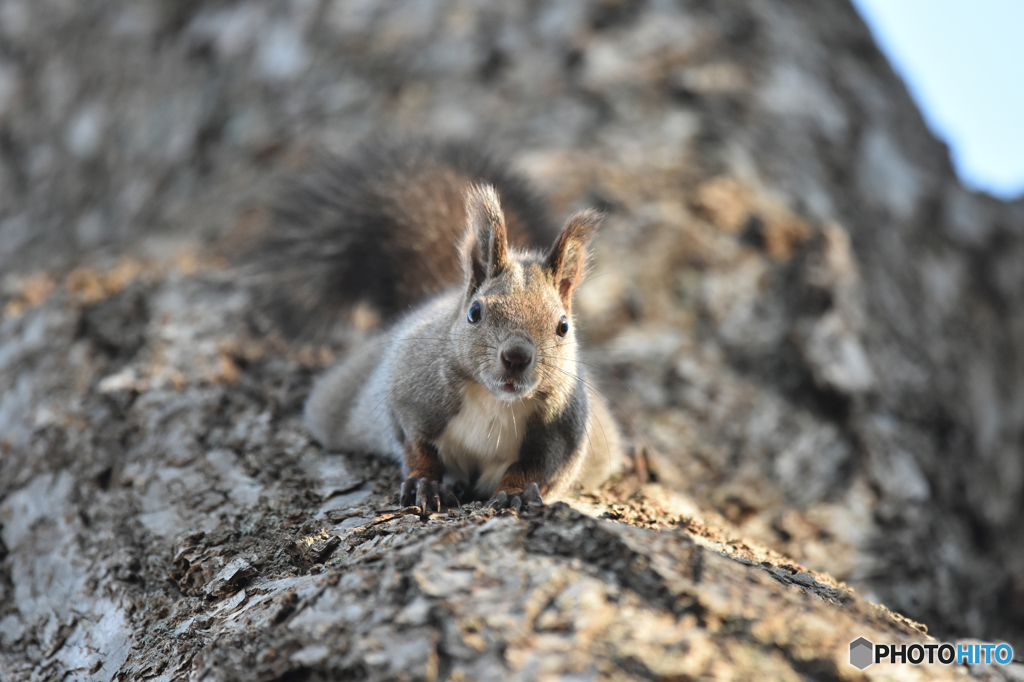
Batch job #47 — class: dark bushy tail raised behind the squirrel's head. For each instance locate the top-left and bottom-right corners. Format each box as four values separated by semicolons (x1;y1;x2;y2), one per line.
248;140;558;338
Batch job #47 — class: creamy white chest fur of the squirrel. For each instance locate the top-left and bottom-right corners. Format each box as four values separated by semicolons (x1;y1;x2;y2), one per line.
434;382;536;495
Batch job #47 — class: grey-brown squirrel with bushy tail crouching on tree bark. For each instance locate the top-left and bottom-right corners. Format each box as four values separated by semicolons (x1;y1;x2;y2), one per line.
256;140;624;513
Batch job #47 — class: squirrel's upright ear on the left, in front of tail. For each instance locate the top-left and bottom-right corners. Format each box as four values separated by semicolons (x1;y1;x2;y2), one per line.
459;184;509;292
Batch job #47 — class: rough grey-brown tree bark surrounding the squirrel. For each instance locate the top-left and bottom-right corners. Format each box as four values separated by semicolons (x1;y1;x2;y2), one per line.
0;0;1024;680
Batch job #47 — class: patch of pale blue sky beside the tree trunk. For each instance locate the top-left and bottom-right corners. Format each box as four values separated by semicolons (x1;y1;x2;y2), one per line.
853;0;1024;199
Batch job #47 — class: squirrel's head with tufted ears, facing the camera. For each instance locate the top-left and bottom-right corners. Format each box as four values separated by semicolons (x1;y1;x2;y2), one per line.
452;185;602;401
